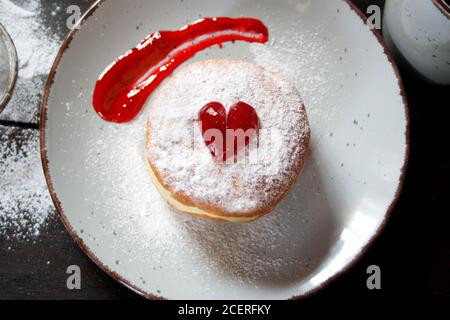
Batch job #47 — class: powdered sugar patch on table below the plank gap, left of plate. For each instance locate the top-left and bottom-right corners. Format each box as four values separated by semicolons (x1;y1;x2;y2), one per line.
0;127;53;240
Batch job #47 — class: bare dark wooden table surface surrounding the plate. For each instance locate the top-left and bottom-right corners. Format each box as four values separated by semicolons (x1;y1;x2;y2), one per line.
0;0;450;302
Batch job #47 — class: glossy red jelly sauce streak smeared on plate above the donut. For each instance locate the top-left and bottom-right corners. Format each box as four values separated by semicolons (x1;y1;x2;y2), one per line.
93;17;269;122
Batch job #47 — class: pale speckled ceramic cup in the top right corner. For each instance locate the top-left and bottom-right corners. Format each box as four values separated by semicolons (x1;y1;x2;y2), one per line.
383;0;450;85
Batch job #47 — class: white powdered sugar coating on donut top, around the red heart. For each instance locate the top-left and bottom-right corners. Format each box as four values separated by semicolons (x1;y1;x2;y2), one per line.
147;60;309;215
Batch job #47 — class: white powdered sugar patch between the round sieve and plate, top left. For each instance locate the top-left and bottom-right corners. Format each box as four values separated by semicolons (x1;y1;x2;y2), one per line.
0;0;59;122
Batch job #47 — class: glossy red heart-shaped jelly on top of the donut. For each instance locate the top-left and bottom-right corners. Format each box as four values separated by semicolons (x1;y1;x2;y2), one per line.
198;101;259;163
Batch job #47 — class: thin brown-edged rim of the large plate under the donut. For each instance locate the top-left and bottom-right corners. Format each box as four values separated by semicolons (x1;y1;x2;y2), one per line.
39;0;410;300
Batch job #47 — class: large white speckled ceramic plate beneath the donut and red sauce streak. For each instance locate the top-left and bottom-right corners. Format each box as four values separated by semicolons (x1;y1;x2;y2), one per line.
41;0;408;299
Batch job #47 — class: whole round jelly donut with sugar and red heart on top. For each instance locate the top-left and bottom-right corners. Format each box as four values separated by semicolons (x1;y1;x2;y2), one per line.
146;59;310;222
